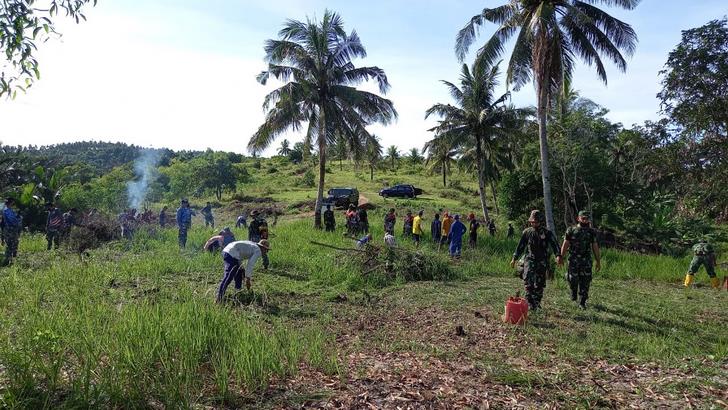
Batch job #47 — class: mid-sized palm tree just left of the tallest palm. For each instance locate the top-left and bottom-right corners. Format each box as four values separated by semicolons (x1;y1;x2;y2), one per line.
425;58;529;219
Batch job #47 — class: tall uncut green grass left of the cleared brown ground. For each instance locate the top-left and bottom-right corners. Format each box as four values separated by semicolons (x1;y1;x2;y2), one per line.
0;229;338;408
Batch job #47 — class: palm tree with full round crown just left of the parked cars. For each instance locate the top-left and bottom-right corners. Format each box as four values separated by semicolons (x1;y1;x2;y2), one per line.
248;10;397;228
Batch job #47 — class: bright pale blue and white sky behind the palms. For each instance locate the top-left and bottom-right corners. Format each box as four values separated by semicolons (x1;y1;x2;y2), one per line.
0;0;728;155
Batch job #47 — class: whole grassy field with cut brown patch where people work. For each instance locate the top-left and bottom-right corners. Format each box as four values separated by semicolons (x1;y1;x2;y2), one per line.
0;164;728;408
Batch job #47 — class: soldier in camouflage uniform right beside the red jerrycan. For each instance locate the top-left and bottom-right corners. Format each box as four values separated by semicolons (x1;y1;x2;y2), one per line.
511;210;561;310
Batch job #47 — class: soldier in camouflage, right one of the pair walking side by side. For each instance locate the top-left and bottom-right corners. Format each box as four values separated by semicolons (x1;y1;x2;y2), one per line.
560;211;602;309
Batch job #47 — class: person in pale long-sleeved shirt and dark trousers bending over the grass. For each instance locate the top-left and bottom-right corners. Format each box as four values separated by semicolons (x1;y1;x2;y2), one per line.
216;239;270;303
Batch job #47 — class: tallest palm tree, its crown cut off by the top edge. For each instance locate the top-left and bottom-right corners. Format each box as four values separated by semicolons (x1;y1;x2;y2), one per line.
455;0;640;230
